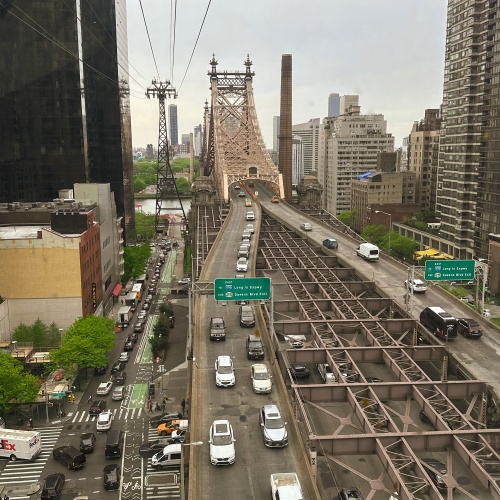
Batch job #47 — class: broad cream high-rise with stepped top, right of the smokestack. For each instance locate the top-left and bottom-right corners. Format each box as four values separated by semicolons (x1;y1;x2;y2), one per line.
318;105;394;215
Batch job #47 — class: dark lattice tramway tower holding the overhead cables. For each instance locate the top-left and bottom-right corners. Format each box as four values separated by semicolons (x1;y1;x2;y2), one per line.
146;79;187;233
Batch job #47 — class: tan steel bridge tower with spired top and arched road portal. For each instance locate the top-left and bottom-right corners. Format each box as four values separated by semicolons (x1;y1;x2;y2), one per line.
206;57;283;201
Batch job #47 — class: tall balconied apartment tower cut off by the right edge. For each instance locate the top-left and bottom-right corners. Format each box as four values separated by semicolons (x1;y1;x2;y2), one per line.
436;0;500;259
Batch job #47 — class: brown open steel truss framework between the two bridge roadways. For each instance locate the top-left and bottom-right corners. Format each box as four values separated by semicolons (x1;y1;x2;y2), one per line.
256;214;500;499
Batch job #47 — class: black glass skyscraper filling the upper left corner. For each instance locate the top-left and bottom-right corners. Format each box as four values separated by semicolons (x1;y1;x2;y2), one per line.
0;0;135;238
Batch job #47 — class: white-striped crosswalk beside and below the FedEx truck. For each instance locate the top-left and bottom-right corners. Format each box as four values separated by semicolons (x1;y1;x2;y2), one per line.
0;425;63;499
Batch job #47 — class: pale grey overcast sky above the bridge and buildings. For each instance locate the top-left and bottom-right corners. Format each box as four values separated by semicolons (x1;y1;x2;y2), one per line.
127;0;447;148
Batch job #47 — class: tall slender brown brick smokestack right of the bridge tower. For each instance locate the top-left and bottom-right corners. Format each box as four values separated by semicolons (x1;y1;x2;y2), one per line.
278;54;292;202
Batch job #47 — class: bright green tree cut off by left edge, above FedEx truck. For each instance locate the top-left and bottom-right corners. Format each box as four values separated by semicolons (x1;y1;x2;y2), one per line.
0;352;38;409
